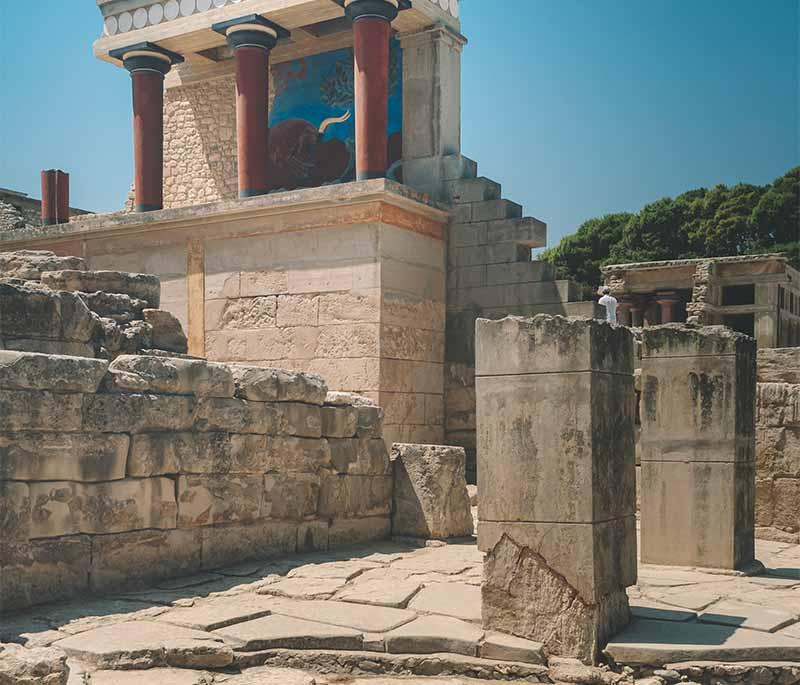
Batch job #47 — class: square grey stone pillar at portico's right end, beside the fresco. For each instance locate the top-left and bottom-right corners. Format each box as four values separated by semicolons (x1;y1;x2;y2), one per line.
400;25;473;199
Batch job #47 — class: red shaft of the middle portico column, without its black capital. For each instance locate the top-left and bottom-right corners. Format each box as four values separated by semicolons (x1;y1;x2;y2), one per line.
235;45;269;197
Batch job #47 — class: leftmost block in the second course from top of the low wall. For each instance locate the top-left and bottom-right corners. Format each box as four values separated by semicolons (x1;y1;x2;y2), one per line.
0;390;83;433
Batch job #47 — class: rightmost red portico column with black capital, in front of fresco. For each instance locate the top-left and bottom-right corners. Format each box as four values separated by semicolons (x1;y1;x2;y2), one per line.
344;0;405;181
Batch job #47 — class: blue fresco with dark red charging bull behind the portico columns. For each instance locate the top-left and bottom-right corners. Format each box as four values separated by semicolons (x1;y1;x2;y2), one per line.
269;41;403;190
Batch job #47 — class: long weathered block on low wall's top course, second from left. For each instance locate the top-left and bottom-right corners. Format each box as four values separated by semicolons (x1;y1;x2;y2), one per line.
106;355;235;398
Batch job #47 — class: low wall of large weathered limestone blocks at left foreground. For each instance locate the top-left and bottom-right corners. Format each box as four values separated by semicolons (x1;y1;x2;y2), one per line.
0;350;392;611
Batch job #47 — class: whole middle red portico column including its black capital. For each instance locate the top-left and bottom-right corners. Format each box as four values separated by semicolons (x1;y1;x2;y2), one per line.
212;14;289;197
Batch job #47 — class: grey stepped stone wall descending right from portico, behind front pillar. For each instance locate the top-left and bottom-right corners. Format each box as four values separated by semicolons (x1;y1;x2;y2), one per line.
442;156;599;483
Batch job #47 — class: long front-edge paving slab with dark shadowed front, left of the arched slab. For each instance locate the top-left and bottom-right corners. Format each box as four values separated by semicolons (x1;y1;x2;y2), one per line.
212;615;363;652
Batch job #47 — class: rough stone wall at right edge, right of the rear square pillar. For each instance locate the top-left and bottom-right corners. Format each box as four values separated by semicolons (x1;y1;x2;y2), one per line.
756;348;800;543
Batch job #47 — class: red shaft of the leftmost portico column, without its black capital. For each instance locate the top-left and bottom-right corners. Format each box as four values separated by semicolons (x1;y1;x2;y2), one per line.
131;69;164;212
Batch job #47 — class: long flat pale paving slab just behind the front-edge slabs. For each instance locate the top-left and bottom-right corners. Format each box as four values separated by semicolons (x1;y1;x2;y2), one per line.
272;598;417;633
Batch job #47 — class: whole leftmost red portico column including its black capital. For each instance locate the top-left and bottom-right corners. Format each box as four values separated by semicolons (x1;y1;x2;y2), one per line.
109;43;183;212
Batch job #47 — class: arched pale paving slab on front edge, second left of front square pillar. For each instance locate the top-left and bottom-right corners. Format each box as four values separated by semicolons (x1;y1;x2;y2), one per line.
386;616;484;656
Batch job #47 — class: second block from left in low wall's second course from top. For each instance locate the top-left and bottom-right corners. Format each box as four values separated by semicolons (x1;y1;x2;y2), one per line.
83;393;197;433
